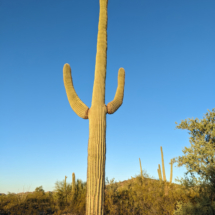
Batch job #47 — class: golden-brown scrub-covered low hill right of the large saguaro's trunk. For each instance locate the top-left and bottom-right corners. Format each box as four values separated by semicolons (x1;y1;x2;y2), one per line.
105;171;202;215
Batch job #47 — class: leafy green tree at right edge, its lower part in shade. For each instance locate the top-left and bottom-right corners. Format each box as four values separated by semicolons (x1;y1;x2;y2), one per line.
173;109;215;205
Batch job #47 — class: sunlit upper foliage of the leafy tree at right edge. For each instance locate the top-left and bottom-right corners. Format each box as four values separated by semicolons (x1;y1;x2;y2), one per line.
174;109;215;180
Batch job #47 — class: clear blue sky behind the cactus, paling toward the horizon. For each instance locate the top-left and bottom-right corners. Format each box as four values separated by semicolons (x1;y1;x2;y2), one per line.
0;0;215;193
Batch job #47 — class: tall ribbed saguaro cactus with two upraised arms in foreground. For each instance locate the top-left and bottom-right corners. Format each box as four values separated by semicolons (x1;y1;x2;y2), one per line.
63;0;125;215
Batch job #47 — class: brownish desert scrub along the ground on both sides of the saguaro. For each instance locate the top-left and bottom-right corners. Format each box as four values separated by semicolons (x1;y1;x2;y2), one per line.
0;174;215;215
